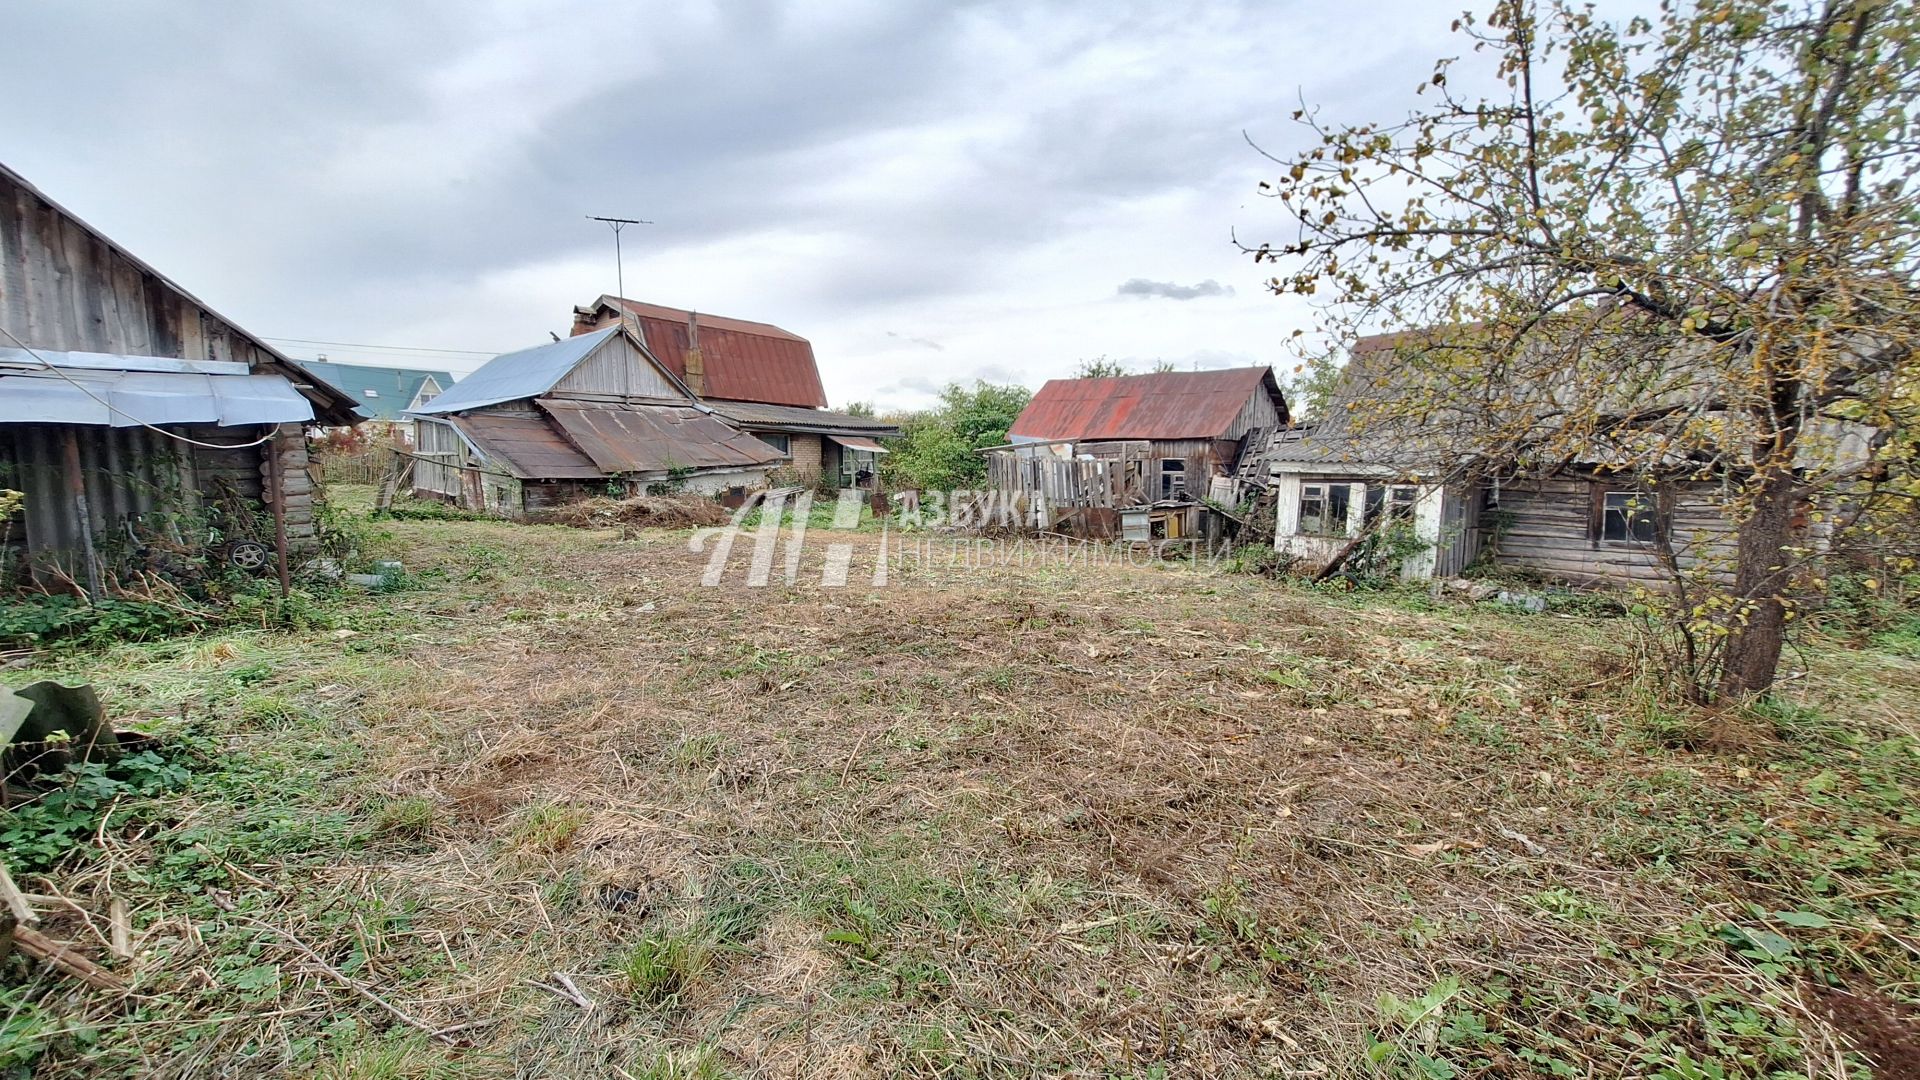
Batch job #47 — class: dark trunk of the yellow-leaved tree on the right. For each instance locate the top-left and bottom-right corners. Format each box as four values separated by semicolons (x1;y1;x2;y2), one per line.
1720;469;1799;701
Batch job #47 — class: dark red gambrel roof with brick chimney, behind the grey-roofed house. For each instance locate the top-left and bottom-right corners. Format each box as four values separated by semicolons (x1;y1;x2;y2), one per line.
574;296;828;407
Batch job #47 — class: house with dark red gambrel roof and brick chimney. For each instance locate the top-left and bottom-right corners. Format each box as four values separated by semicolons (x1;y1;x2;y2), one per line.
574;296;900;478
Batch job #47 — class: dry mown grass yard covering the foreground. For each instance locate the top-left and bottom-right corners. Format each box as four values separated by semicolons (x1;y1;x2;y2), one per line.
0;490;1920;1080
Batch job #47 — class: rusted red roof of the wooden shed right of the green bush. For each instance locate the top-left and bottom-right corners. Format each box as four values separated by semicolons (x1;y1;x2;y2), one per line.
1008;367;1286;440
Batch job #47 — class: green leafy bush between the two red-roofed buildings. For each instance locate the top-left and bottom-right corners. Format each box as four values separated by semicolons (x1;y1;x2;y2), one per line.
881;382;1033;492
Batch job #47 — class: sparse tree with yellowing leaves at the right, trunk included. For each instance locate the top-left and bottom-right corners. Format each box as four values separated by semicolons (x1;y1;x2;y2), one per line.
1254;0;1920;698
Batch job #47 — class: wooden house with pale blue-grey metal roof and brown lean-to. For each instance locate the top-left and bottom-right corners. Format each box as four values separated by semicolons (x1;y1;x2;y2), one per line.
413;325;785;517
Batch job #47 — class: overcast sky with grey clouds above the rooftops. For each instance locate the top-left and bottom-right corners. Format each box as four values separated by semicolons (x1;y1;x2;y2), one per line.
0;0;1457;407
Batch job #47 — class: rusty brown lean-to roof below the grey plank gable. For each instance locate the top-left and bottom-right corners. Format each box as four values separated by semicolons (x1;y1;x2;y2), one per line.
538;398;783;473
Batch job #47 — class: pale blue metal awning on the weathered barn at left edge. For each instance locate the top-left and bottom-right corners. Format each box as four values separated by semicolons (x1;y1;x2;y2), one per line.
0;363;313;427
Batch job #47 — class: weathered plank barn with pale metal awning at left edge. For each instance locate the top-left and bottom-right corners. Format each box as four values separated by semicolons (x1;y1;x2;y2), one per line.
0;165;363;592
